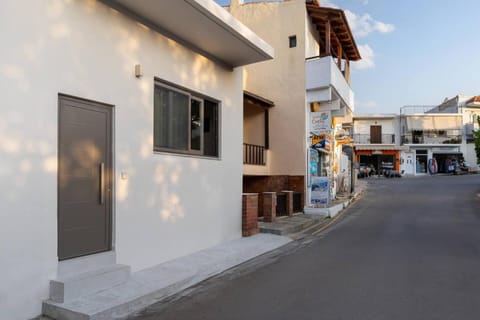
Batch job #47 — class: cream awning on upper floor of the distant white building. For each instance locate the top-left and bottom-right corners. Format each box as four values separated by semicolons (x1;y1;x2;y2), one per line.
406;115;462;131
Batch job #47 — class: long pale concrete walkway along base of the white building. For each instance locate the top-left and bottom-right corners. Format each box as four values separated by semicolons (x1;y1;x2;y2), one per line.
42;234;292;320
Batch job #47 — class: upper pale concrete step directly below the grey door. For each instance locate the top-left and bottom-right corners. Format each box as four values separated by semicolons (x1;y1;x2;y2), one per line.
50;264;130;303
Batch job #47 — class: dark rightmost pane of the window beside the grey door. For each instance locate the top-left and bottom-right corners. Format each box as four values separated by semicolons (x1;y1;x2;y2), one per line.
203;100;218;157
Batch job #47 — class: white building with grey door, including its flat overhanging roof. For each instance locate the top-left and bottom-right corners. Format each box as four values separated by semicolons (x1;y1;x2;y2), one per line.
0;0;273;320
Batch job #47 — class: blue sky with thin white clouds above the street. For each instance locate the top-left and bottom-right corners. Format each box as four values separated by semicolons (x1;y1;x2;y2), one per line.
216;0;480;114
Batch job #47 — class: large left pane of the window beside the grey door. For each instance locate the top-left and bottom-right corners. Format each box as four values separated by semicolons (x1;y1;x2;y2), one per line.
154;87;189;150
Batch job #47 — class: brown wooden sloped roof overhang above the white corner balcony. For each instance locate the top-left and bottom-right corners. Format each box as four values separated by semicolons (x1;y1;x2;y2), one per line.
306;1;362;61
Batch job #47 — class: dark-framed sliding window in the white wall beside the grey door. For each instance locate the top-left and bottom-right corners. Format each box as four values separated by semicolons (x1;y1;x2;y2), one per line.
153;83;219;158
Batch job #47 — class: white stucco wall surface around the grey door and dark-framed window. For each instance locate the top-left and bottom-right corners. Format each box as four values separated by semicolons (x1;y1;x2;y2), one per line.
0;0;244;320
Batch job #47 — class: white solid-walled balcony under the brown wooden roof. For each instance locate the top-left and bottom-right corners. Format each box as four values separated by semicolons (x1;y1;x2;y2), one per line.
305;56;354;111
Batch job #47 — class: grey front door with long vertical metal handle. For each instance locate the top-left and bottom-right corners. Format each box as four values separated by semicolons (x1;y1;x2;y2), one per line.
58;96;113;260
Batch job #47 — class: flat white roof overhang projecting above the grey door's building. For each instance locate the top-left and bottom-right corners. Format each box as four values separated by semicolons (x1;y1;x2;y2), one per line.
101;0;274;68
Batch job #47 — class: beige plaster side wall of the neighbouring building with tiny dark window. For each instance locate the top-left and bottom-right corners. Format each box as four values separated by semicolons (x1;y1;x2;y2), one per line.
229;0;306;176
